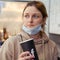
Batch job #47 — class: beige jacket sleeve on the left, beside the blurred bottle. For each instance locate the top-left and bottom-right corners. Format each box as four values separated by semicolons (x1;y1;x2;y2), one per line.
0;38;14;60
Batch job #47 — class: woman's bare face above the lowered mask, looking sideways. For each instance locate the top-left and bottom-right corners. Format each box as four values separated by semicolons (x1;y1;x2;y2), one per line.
23;6;43;28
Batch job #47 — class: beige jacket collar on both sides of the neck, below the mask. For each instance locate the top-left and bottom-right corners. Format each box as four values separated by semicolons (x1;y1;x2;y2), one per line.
20;30;49;44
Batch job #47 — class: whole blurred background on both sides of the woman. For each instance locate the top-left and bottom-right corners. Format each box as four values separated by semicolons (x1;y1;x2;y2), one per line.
0;0;60;57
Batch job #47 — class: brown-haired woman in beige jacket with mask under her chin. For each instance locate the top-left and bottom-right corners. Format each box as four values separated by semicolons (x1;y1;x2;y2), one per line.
0;1;57;60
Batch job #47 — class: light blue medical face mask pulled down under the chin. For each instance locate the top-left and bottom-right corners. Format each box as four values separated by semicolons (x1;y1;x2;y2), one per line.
22;25;42;35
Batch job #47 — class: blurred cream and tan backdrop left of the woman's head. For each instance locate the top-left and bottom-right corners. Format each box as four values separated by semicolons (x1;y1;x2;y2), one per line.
0;2;26;35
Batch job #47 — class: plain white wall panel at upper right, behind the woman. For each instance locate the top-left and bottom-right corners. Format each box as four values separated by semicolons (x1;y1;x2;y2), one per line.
49;0;60;34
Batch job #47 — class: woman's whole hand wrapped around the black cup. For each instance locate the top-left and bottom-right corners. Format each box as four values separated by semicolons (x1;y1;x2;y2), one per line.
18;51;34;60
